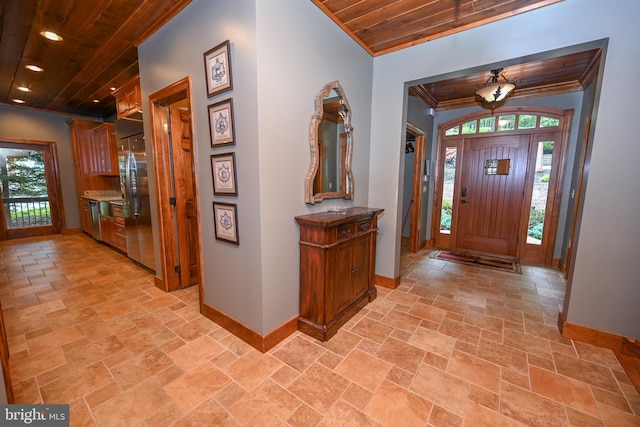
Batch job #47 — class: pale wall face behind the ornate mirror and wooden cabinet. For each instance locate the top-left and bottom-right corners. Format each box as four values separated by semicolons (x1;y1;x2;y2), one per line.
257;0;373;331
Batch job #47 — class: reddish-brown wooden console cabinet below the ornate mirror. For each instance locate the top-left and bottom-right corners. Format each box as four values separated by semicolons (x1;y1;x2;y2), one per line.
296;207;383;341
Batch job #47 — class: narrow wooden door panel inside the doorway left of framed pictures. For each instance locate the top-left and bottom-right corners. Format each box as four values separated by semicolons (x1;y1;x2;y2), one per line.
170;108;200;287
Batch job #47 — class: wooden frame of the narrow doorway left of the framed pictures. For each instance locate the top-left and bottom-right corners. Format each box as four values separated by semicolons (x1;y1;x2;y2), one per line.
149;77;203;294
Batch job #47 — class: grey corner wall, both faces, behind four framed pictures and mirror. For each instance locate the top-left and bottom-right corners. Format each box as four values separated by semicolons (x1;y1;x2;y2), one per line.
138;0;373;334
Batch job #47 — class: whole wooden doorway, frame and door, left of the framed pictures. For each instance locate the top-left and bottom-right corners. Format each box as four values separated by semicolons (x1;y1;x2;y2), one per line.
149;78;202;295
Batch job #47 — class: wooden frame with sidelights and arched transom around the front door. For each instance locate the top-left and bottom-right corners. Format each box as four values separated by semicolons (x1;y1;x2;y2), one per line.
431;107;574;267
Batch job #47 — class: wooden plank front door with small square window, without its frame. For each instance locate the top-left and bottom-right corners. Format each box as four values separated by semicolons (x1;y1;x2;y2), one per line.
456;135;529;256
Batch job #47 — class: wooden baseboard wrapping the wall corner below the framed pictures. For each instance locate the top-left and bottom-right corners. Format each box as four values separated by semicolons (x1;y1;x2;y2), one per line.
202;303;298;353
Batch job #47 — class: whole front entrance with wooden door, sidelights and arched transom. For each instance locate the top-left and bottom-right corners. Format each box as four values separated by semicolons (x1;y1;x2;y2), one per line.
432;107;573;266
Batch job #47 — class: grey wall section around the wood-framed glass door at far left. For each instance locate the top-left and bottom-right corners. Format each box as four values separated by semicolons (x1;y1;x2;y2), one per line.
0;105;91;229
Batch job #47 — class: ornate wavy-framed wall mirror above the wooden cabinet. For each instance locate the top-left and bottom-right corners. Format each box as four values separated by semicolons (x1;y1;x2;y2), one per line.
304;81;353;204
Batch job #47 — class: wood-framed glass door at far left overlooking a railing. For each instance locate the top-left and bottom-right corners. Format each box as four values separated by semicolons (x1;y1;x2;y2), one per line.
0;139;64;240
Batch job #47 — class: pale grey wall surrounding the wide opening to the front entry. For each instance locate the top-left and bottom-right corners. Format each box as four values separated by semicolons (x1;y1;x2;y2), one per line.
369;0;640;337
